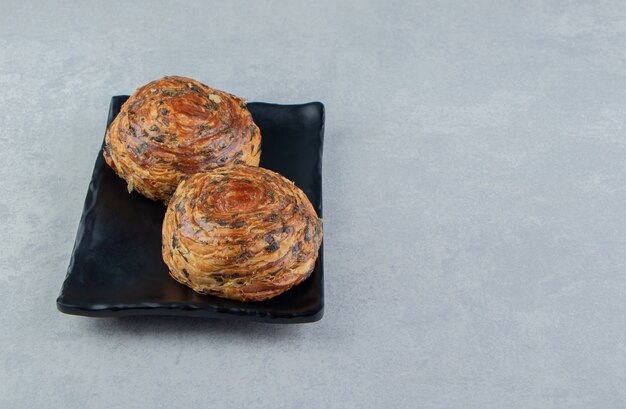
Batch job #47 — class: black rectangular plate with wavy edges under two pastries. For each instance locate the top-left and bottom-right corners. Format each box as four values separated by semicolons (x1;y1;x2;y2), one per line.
57;96;324;323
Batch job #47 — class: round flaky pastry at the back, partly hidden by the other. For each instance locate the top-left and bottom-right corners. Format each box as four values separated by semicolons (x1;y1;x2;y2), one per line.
104;76;261;202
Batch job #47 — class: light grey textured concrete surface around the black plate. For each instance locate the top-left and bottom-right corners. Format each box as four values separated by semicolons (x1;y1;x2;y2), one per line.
0;0;626;409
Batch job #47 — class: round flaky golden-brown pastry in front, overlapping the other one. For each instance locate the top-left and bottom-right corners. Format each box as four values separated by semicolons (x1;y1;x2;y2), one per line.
163;165;323;301
